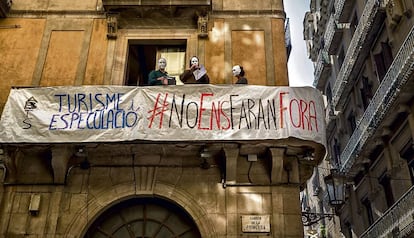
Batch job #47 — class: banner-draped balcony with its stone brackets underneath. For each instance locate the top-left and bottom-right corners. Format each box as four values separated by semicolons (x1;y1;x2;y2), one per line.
0;84;326;186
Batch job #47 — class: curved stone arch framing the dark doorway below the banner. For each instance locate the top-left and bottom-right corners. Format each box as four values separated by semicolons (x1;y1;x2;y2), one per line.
64;183;218;238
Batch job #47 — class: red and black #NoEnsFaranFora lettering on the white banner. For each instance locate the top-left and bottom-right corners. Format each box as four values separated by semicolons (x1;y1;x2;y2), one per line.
147;91;319;132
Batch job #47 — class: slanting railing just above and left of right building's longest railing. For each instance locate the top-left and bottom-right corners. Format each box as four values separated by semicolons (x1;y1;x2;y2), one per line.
332;0;386;108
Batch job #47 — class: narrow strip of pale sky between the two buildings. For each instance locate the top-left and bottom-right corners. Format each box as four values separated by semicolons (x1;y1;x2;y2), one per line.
283;0;314;86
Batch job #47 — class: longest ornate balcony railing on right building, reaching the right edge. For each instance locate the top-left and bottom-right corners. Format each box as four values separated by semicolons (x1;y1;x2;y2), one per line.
341;24;414;172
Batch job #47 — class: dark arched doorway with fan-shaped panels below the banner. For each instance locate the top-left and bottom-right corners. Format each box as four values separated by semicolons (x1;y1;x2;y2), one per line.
84;197;201;238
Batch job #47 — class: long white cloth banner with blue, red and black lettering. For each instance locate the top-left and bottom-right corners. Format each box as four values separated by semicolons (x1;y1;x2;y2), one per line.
0;85;326;146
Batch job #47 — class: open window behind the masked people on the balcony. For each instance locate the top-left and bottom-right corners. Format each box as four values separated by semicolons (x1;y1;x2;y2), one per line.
125;40;186;86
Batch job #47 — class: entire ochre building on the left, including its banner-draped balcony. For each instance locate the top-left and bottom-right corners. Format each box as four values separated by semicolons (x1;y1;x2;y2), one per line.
0;0;325;238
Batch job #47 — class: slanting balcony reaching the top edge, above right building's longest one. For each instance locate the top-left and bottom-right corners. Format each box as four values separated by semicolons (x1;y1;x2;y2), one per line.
332;0;386;111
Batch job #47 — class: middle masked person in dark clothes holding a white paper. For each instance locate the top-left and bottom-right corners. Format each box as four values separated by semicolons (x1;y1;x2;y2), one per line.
180;56;210;84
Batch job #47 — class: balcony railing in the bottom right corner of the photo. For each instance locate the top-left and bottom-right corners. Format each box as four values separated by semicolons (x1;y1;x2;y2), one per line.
361;186;414;238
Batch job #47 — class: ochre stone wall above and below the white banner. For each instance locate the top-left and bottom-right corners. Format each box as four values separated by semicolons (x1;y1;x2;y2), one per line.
0;0;323;238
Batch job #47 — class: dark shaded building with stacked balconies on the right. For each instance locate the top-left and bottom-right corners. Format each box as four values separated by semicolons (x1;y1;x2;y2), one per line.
303;0;414;237
